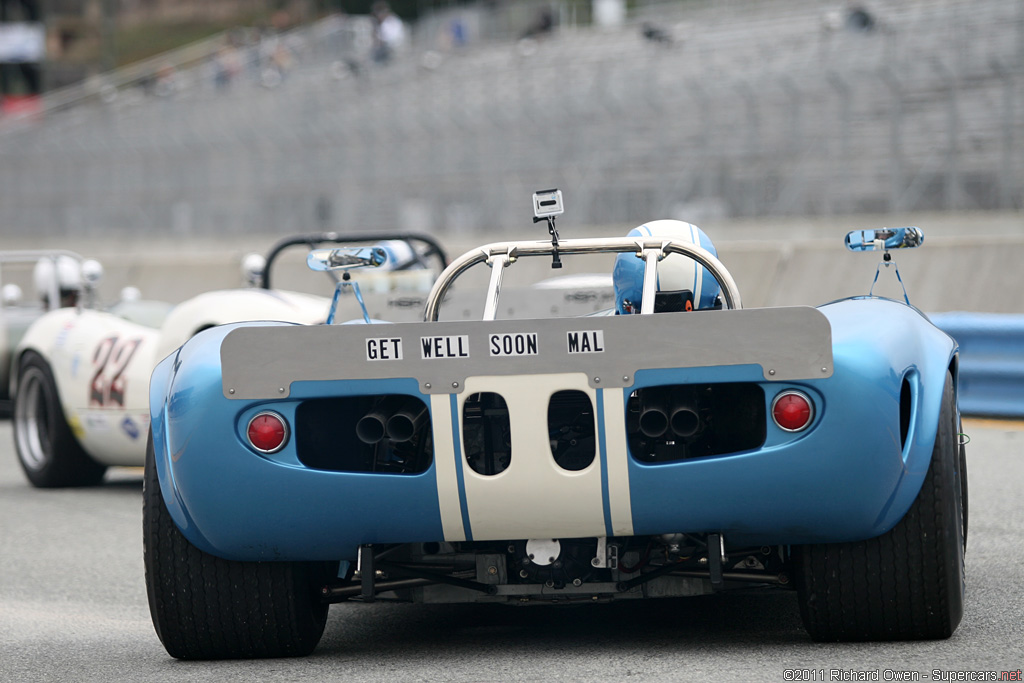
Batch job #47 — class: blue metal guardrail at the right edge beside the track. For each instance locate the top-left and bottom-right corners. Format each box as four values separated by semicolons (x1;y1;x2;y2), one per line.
930;312;1024;418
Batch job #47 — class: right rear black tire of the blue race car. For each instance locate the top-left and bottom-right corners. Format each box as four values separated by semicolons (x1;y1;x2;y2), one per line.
794;374;967;641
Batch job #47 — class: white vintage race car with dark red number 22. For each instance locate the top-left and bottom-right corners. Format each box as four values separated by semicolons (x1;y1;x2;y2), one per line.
4;233;446;487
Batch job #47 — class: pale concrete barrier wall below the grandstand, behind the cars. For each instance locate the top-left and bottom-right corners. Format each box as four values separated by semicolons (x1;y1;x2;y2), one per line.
3;213;1024;313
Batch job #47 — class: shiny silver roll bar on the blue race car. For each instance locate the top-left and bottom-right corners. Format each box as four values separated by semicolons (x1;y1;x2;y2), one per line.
423;237;742;323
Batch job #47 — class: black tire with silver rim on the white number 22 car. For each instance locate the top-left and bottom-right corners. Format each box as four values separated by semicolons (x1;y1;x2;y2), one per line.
13;351;106;488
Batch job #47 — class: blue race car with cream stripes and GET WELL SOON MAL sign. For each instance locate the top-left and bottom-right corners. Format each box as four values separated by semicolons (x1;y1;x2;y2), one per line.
143;211;967;658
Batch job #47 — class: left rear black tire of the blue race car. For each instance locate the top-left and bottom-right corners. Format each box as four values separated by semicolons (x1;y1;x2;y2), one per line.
142;434;329;659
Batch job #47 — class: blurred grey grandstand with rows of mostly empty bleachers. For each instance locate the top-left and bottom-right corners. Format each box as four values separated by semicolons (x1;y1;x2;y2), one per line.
0;0;1024;239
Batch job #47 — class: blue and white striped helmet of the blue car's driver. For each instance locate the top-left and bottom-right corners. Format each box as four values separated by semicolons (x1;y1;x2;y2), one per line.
611;220;721;313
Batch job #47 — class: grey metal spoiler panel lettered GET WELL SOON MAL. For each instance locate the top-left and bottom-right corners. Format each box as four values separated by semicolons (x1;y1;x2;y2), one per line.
220;306;833;399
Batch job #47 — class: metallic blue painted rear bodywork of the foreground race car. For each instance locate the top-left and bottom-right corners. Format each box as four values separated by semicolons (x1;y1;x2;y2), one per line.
151;298;957;560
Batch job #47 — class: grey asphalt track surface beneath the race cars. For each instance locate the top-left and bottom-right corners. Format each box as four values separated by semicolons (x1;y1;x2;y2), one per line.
0;421;1024;683
